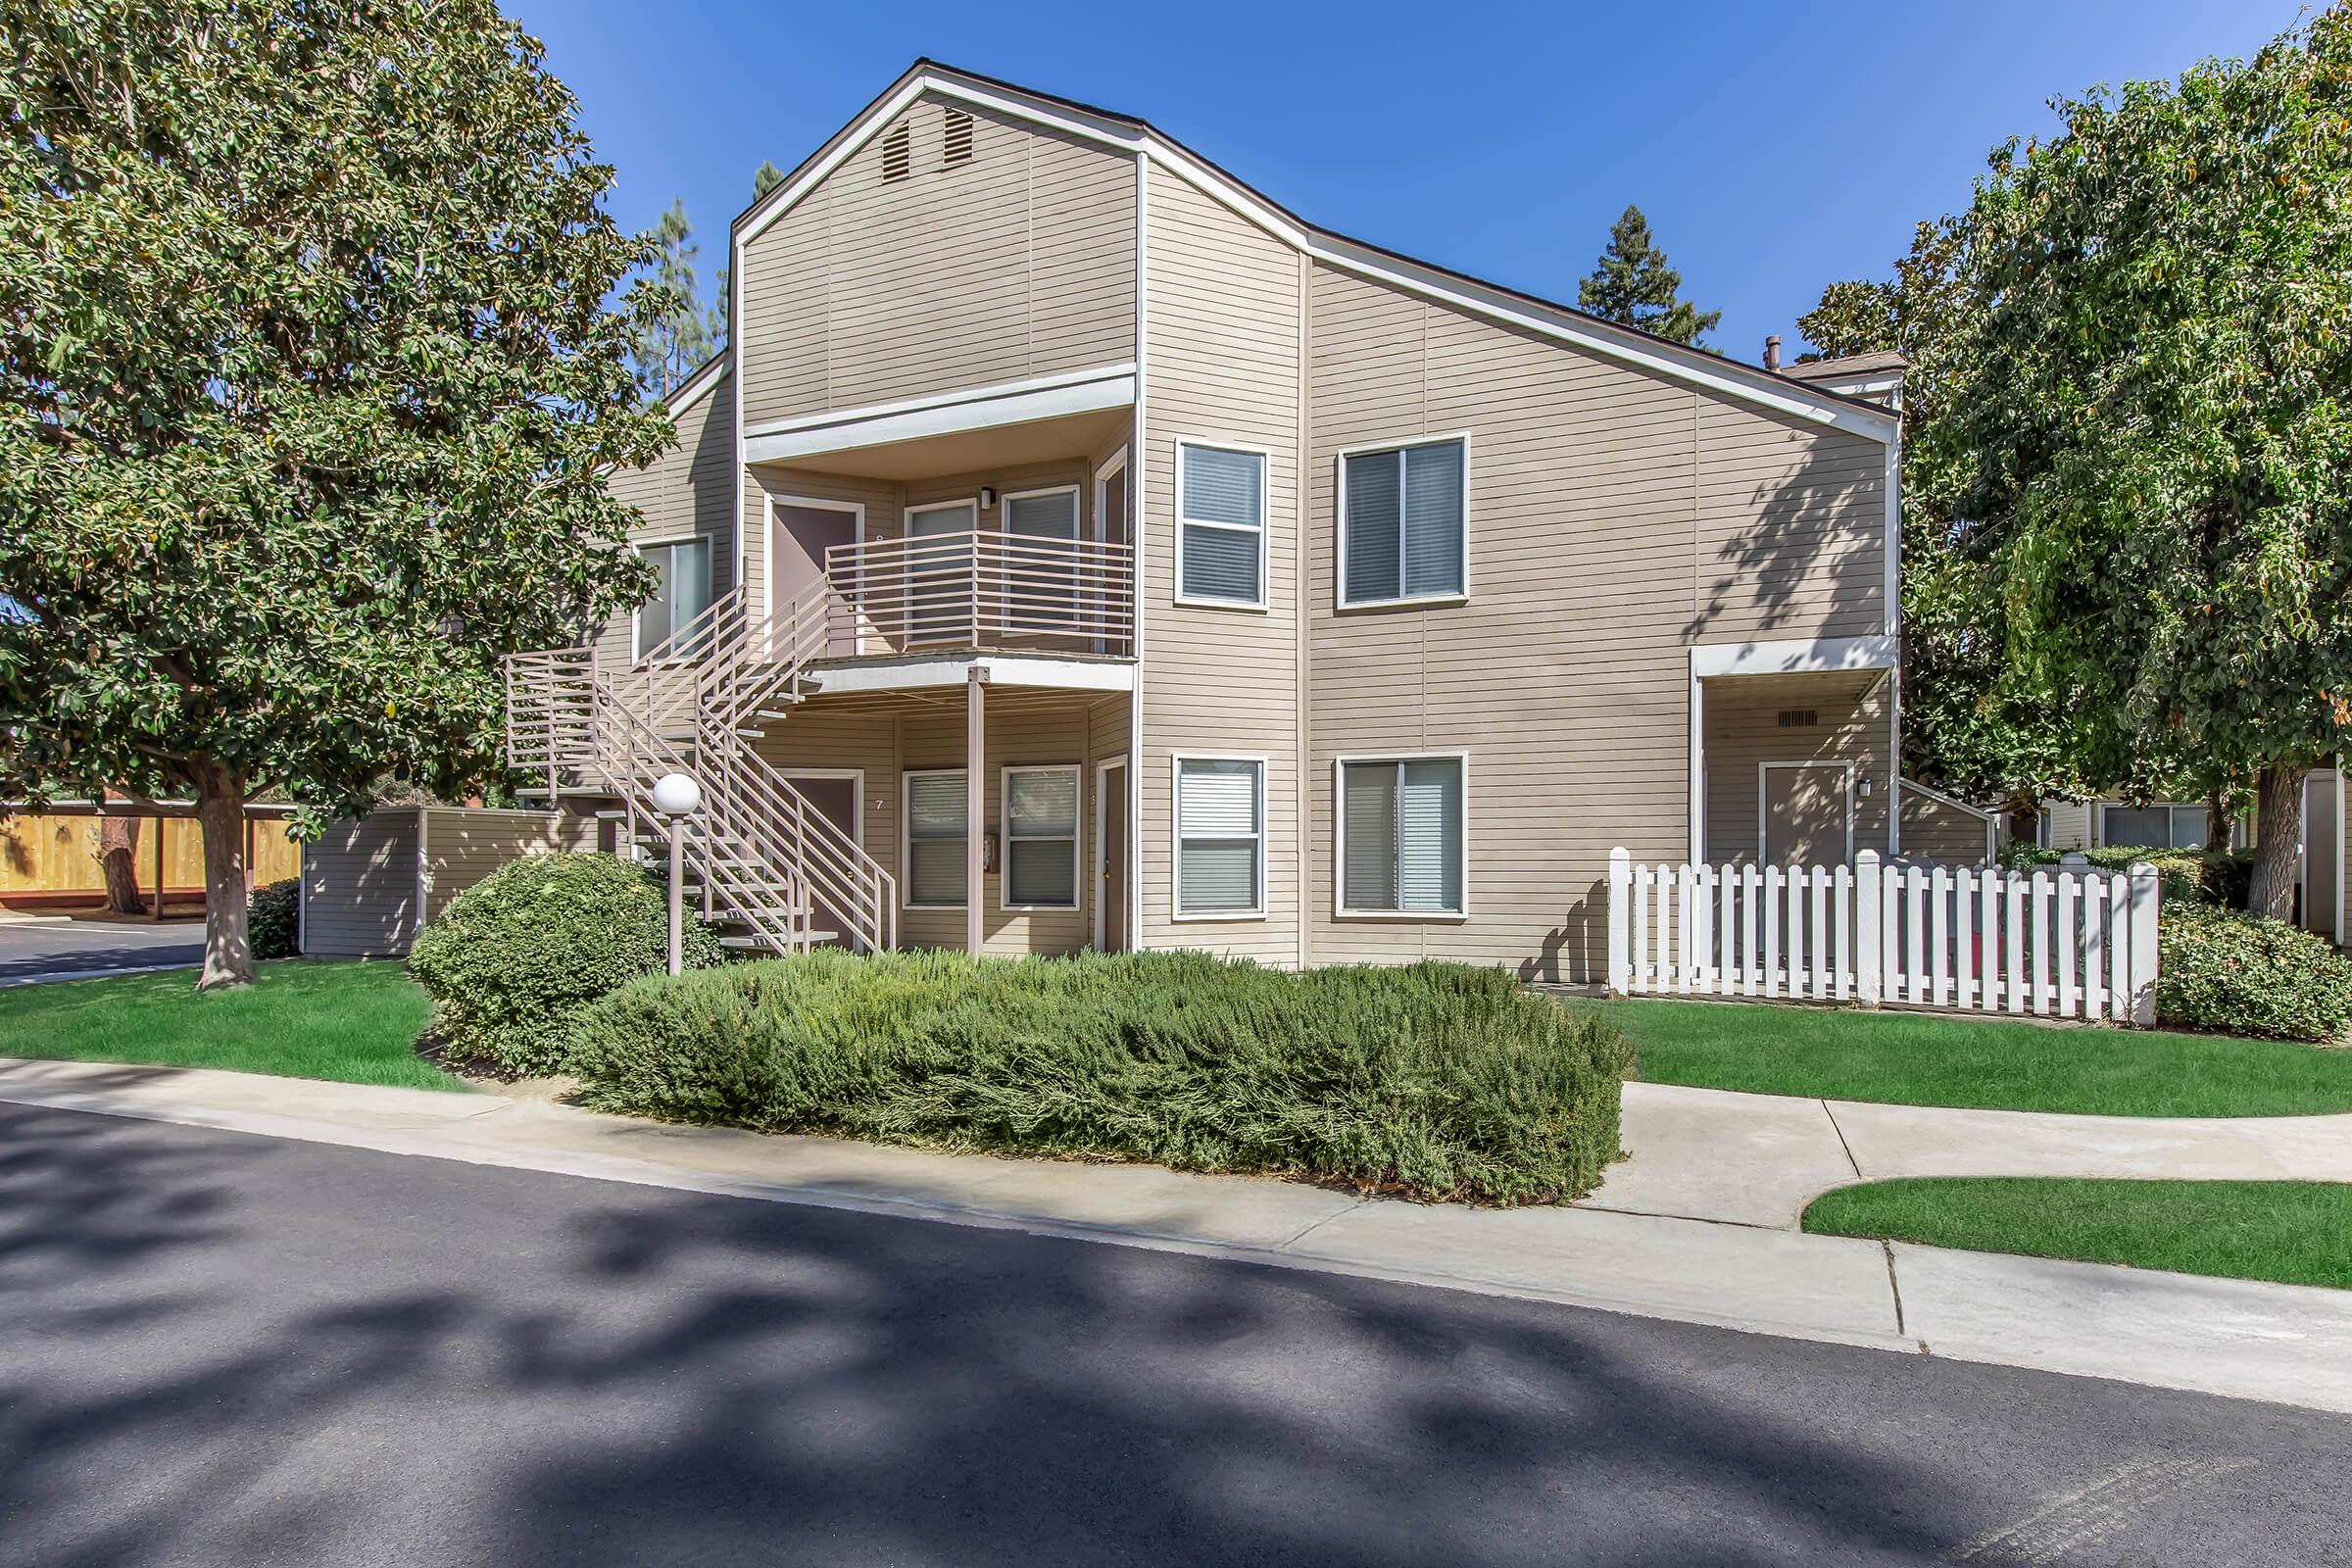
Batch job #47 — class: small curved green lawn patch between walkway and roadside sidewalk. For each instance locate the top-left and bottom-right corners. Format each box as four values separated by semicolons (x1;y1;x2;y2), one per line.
1804;1178;2352;1289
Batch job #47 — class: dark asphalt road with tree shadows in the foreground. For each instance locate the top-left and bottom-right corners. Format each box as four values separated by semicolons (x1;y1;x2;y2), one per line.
0;1104;2352;1568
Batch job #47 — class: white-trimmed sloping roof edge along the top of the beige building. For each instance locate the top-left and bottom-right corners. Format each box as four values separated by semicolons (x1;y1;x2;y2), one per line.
731;59;1895;442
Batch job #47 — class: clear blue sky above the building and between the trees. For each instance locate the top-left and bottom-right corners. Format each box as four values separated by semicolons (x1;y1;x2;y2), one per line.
508;0;2303;360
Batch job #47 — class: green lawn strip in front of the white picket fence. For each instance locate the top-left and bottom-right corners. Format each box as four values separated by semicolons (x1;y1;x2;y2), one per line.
1592;1002;2352;1116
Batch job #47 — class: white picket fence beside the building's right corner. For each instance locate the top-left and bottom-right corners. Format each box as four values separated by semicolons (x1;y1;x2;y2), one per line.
1609;849;2157;1025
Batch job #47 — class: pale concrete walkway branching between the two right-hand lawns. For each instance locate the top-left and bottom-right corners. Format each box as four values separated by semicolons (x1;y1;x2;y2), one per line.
1583;1084;2352;1230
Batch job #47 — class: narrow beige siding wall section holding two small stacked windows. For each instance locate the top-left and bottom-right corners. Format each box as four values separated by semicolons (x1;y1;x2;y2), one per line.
1136;170;1303;964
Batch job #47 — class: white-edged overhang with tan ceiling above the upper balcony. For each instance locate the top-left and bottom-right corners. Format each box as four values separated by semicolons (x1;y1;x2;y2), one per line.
743;365;1136;479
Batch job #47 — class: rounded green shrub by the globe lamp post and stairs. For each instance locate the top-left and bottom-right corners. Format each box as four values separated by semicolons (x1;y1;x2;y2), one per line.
410;854;727;1077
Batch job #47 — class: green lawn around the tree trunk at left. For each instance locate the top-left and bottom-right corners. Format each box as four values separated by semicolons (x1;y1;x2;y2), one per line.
0;959;466;1091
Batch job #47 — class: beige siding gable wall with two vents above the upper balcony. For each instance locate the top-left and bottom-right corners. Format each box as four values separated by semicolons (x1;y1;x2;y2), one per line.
739;99;1136;428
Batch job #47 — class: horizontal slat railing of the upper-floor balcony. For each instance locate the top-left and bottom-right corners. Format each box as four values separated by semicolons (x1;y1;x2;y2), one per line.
825;534;1136;659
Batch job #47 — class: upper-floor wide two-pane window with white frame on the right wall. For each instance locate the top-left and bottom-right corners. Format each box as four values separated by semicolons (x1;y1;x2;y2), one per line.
1339;437;1468;604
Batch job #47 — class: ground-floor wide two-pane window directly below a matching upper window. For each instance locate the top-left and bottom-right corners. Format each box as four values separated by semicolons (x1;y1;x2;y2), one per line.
1336;757;1463;914
